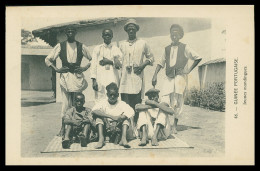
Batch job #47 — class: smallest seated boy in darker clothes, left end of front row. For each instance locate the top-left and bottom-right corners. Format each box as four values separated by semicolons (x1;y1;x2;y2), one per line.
62;93;94;148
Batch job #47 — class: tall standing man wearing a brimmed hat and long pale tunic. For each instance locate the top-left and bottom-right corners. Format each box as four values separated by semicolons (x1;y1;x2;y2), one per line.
119;19;154;130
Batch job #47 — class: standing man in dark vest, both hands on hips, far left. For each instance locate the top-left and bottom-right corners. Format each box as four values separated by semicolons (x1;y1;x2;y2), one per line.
45;26;92;136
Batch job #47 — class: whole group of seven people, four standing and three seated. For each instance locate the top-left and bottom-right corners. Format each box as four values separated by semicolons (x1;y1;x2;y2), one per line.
45;19;201;149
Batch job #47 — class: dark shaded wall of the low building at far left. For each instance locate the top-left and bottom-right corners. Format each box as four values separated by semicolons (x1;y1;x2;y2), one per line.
21;55;52;91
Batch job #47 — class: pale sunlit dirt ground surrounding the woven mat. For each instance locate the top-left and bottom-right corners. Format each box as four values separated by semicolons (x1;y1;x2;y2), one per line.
21;92;225;158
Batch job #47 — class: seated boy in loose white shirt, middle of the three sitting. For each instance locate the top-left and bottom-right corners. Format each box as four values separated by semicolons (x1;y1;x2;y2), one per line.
92;83;134;149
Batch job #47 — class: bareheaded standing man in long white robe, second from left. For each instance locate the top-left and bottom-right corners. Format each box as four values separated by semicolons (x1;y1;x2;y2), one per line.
90;29;122;101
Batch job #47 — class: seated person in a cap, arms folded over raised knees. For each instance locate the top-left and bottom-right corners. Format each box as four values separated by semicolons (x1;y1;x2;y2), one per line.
135;88;174;146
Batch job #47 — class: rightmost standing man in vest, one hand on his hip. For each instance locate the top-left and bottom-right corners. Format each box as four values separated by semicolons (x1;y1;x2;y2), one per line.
152;24;201;134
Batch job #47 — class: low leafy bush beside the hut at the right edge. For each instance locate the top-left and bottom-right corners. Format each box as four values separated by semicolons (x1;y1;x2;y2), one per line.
184;82;226;111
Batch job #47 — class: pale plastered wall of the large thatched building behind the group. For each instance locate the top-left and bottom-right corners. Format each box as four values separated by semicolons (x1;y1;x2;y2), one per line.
57;18;211;102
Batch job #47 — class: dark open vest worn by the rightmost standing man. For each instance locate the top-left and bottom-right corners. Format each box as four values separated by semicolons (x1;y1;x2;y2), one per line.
165;43;188;78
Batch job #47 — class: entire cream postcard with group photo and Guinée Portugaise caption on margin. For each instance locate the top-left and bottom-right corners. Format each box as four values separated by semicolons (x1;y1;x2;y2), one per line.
5;5;255;165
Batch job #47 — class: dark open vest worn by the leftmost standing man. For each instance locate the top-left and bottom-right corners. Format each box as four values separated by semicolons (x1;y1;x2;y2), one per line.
60;41;83;73
